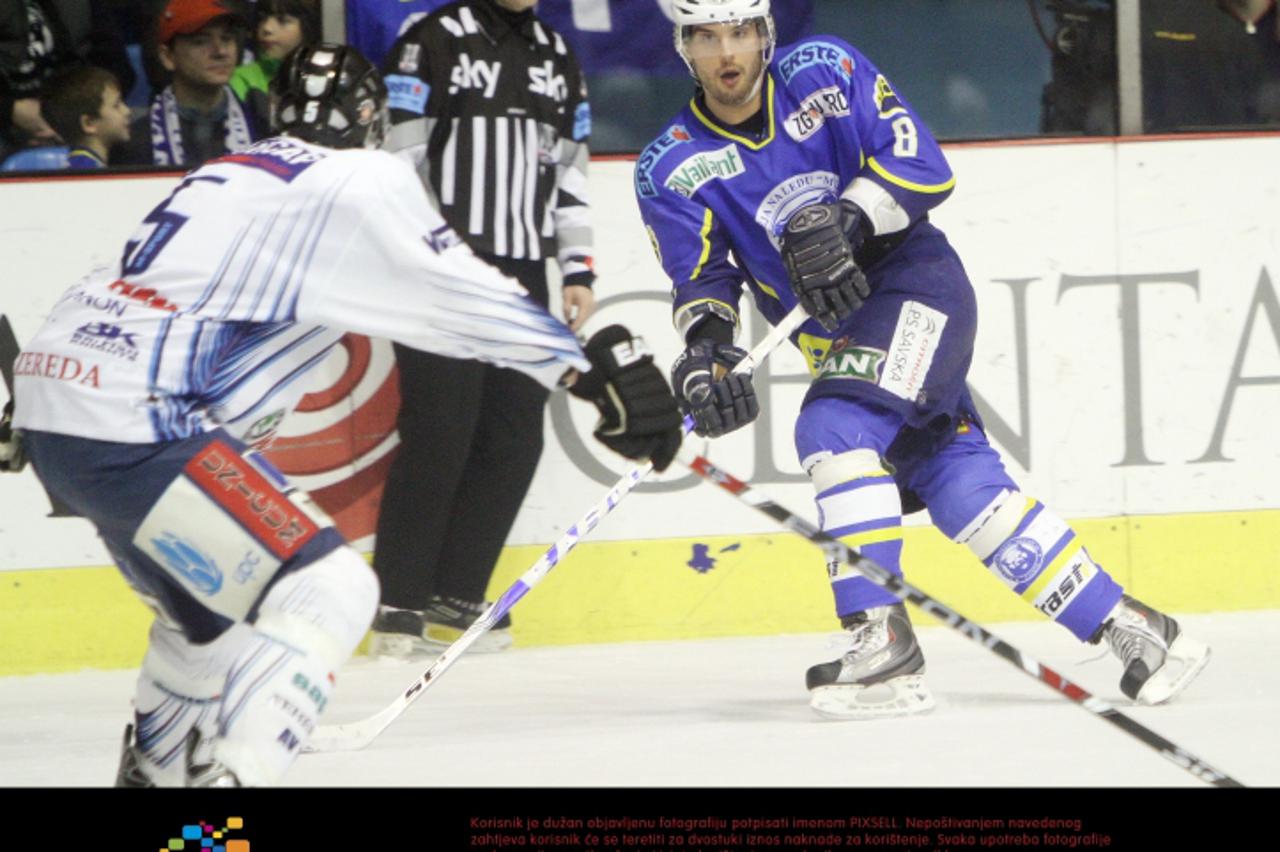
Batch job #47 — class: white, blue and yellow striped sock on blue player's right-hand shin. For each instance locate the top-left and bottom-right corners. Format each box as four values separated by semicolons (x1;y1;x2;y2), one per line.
955;489;1120;640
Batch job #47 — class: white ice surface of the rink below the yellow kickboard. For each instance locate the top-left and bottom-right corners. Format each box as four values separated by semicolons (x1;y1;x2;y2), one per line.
0;609;1280;787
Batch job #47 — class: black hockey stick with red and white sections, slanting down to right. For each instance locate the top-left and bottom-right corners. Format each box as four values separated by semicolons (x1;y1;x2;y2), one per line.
677;450;1244;787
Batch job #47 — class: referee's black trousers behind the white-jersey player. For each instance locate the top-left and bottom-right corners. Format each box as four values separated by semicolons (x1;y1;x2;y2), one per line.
374;256;549;610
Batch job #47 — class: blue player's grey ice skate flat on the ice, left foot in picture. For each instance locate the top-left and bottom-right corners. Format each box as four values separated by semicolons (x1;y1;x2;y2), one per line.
805;604;934;719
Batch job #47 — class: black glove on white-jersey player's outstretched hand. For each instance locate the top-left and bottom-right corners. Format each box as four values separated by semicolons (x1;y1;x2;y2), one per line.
568;325;685;471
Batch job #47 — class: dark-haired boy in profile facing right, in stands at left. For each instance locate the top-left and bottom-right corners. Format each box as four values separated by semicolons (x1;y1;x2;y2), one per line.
41;65;131;169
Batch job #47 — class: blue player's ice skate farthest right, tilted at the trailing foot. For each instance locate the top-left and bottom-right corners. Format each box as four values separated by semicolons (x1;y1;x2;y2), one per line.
1102;595;1210;704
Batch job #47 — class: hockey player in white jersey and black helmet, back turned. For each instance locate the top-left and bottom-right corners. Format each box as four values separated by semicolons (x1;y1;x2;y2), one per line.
5;45;682;785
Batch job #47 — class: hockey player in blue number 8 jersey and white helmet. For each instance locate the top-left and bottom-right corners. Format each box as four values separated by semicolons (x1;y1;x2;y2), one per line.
635;0;1208;719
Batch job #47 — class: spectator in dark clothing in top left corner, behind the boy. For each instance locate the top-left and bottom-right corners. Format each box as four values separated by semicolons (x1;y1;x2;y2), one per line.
0;0;134;155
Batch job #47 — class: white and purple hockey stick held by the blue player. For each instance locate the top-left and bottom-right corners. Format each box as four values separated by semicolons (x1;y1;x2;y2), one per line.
302;304;808;752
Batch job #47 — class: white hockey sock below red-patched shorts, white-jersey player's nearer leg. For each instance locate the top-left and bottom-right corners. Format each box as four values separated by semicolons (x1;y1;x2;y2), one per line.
214;548;378;787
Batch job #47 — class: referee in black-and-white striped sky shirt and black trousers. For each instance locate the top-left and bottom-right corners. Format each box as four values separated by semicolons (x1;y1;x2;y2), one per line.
371;0;595;658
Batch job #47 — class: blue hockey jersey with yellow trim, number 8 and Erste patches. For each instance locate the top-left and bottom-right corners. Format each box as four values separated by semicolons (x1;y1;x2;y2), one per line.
635;36;955;371
